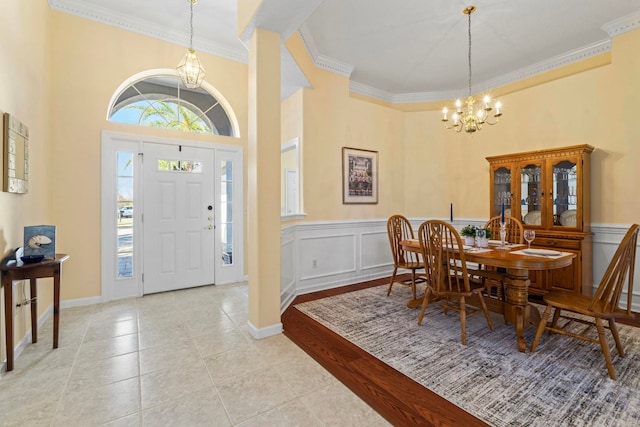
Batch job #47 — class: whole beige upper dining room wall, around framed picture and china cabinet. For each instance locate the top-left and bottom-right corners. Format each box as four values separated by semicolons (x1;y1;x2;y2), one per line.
287;30;640;224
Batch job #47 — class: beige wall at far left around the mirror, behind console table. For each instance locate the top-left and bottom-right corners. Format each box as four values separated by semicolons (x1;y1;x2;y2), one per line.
0;0;55;364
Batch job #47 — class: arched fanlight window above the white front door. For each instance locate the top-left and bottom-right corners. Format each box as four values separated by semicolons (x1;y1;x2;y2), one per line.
108;70;238;137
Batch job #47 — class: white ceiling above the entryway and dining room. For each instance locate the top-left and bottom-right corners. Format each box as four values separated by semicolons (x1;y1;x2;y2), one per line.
49;0;640;102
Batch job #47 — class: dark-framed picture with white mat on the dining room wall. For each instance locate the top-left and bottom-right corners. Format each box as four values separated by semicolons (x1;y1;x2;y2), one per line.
342;147;378;204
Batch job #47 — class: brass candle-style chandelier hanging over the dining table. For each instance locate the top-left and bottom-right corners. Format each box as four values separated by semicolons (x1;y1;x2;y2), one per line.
442;6;502;133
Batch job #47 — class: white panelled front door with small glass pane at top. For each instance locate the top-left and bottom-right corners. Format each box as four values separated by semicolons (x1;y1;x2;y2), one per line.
143;142;216;294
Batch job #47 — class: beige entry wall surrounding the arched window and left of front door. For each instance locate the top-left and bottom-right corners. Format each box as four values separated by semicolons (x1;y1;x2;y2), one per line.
45;12;247;306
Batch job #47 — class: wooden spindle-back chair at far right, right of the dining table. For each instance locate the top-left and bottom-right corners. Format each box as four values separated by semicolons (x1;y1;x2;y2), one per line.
531;224;638;380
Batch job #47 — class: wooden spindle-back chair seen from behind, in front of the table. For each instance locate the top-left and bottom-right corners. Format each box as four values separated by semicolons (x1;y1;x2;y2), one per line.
418;220;493;344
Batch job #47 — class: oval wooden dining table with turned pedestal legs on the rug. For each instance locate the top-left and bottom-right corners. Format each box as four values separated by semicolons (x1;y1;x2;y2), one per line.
400;239;576;352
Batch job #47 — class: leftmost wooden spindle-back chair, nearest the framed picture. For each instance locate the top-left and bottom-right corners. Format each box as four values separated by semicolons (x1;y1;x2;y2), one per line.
387;215;424;299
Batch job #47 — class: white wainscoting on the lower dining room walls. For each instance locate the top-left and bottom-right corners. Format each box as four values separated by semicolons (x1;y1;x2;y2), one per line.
281;218;640;312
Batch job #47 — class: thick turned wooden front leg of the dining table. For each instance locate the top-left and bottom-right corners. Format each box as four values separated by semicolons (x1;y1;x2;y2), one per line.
504;268;530;353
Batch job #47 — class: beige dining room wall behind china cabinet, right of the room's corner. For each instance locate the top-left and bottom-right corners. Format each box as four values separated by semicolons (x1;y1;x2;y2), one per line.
404;30;640;224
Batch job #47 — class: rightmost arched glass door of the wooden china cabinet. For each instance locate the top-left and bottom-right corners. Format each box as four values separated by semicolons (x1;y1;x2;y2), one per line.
551;160;579;227
